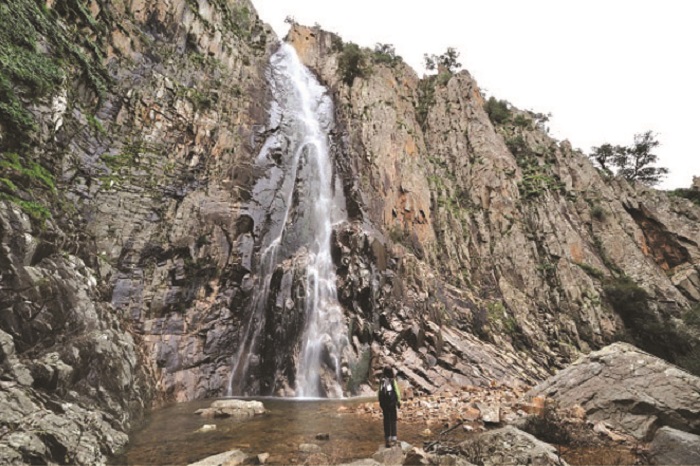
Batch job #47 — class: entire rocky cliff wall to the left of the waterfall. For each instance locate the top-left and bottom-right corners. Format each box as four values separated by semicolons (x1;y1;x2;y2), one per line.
0;0;275;464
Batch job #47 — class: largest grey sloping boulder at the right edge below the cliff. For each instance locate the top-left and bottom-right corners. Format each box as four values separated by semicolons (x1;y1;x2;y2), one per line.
529;343;700;440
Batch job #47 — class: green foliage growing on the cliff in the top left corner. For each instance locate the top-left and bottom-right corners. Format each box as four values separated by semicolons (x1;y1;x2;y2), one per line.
0;0;109;149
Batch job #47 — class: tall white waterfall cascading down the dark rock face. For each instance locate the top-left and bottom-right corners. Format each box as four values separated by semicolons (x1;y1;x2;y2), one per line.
228;44;348;397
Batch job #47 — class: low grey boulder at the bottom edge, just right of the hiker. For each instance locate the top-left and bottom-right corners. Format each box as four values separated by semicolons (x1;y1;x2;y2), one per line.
459;426;567;466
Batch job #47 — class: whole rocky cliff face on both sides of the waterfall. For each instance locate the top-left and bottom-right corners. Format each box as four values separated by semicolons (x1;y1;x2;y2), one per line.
0;0;700;463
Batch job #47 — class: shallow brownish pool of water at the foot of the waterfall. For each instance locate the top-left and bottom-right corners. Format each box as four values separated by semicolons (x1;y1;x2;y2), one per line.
113;398;425;465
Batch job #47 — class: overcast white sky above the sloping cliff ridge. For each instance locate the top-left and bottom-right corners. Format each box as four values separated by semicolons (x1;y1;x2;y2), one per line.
252;0;700;189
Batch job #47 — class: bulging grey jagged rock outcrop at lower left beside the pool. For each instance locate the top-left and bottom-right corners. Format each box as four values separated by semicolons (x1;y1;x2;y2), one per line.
0;203;151;464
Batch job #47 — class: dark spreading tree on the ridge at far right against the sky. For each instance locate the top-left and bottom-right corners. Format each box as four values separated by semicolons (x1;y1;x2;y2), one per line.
589;131;668;186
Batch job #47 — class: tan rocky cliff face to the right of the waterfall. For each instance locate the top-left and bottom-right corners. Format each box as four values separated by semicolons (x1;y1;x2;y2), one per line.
288;26;700;388
